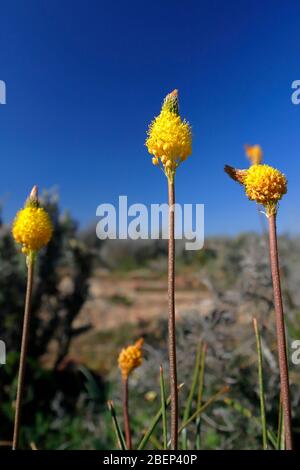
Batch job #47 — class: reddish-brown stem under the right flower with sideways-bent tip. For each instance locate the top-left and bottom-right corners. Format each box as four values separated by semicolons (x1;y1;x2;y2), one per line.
268;214;293;450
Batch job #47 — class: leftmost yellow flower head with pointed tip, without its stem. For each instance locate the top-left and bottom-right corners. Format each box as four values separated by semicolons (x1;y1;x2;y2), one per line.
12;186;53;257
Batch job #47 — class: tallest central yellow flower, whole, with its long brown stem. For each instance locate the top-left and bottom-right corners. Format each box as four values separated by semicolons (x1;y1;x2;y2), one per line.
146;90;192;450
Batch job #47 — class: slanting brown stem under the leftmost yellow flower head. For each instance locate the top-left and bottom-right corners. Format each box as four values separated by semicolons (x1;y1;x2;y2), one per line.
12;256;34;450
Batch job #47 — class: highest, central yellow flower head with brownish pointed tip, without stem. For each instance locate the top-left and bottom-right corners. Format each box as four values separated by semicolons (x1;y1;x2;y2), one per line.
146;90;192;179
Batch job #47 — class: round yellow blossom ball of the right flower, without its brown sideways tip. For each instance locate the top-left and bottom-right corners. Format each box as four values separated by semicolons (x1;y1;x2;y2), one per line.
244;165;287;205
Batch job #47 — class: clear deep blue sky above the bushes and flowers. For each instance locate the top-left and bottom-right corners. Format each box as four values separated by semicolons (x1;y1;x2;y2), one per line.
0;0;300;234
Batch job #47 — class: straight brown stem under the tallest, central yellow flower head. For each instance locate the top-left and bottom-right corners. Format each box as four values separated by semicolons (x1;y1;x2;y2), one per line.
168;177;178;450
